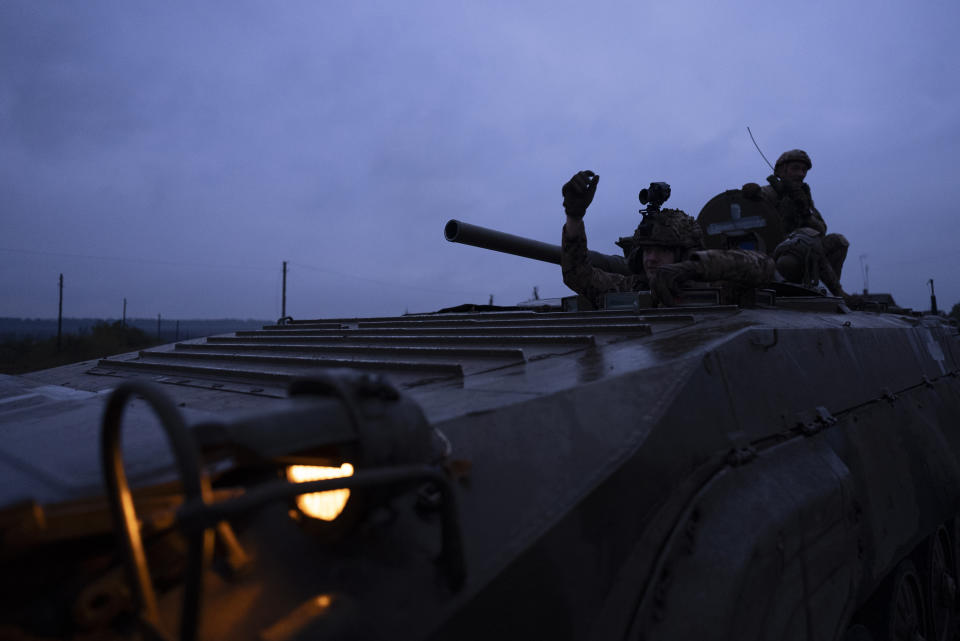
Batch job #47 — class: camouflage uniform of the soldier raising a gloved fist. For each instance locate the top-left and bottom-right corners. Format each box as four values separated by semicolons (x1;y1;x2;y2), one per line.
560;215;774;307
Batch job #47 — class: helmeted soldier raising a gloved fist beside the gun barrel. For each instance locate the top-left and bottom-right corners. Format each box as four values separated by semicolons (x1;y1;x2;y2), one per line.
560;171;775;307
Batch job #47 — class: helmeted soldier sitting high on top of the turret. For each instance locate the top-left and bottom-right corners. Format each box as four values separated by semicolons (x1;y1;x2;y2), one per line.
742;149;850;284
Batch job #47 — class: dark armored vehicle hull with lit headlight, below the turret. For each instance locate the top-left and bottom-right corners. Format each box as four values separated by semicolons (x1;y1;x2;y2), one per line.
0;195;960;641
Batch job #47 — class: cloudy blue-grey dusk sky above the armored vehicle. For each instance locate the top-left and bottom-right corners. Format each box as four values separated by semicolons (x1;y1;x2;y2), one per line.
0;0;960;319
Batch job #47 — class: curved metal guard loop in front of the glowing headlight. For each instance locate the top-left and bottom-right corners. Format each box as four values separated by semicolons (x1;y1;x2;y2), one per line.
100;381;213;641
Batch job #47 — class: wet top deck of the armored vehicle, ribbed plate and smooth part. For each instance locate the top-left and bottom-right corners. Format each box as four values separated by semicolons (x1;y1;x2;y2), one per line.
80;306;936;430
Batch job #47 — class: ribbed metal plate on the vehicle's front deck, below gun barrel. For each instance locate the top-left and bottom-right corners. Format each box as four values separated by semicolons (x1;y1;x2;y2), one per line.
97;312;668;387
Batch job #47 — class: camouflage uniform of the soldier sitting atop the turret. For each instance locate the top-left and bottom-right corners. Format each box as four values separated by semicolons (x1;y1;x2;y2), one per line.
744;149;850;282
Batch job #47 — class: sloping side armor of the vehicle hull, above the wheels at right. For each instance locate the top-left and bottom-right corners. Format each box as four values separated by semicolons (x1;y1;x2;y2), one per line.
432;312;960;639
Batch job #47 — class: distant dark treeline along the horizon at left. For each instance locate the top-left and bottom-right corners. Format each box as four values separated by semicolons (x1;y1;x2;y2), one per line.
0;317;273;342
